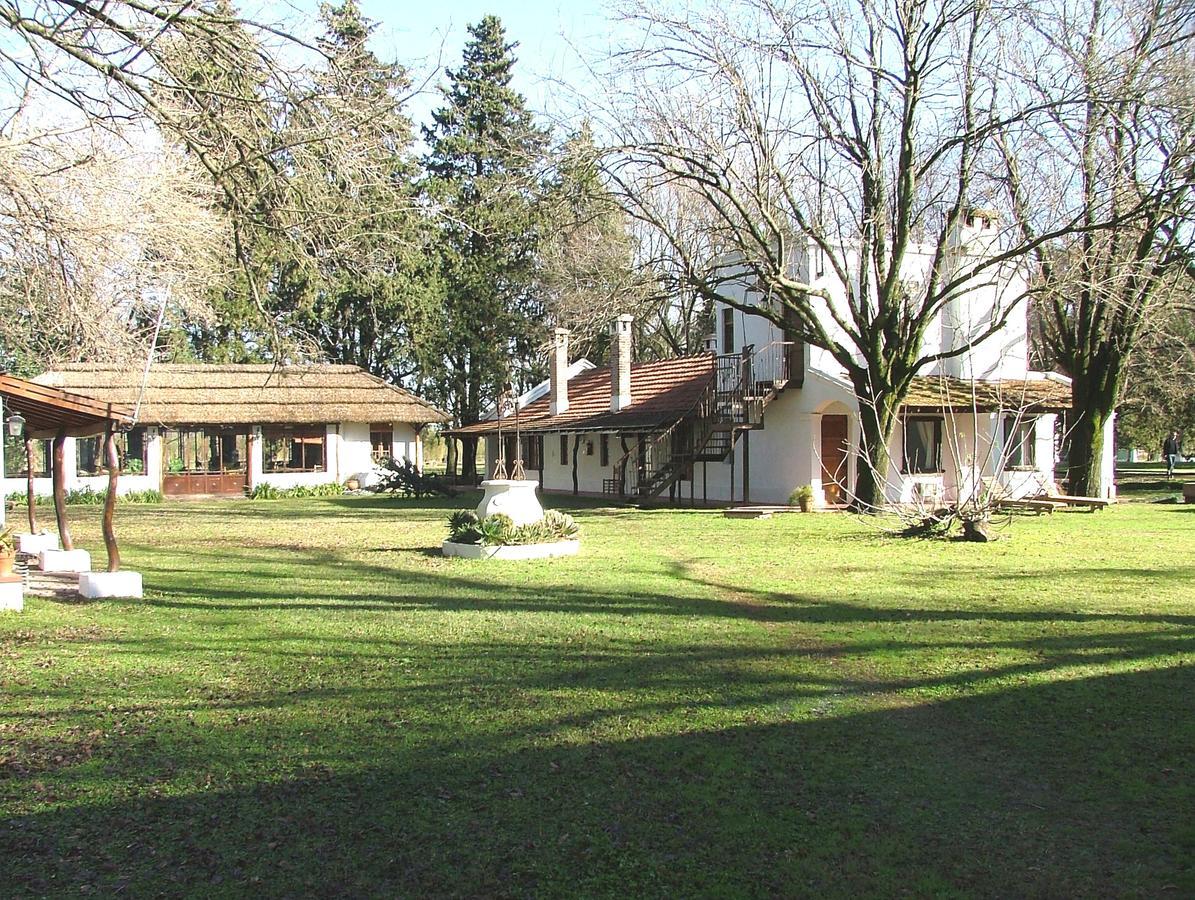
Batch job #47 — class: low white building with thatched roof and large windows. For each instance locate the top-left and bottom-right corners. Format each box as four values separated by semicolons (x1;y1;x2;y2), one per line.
4;363;448;496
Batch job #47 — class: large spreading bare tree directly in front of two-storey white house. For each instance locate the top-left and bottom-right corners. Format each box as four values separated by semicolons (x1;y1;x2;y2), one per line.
602;0;1161;508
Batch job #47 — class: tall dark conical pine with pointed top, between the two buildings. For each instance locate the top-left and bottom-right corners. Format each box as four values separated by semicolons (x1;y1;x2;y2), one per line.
421;16;547;476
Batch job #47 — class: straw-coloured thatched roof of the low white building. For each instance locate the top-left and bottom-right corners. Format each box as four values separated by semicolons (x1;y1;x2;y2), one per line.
33;363;448;425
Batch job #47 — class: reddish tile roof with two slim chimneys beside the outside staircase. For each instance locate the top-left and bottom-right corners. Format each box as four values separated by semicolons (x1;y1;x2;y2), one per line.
452;354;715;434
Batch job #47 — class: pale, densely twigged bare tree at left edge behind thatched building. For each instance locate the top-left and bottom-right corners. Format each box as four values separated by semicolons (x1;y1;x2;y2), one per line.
0;123;231;369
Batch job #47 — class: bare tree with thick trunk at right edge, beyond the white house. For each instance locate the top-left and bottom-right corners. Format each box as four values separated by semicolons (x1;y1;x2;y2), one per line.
1004;0;1195;495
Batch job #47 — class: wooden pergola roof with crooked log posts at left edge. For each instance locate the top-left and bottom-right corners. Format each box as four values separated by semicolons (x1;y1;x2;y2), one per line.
0;374;133;571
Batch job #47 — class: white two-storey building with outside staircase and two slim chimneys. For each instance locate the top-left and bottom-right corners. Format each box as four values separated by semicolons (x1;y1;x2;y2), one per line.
454;214;1113;506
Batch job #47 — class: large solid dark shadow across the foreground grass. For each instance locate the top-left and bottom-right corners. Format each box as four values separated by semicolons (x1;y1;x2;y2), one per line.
0;667;1195;896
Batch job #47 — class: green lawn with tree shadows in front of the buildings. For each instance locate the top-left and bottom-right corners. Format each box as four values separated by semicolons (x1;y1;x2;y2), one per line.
0;500;1195;896
